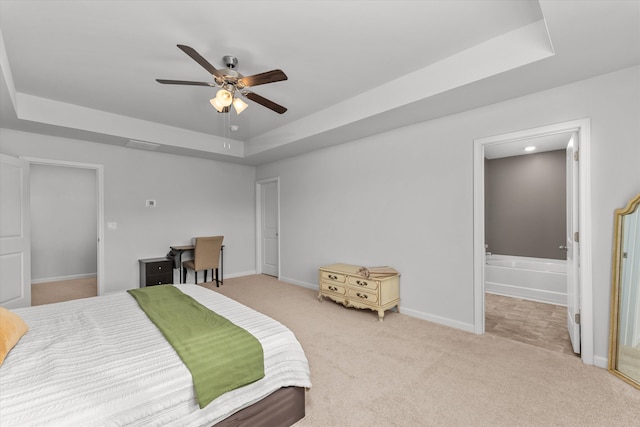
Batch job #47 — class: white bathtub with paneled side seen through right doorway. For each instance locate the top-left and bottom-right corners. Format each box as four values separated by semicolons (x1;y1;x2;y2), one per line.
484;255;567;305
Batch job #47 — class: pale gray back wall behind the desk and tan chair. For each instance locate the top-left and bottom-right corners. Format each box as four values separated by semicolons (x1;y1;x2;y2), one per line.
0;129;255;292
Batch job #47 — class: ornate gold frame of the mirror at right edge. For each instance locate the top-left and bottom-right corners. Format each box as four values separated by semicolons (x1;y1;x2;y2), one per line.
609;194;640;389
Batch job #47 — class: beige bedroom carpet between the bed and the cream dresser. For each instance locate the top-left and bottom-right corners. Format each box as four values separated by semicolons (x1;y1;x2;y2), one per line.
207;275;640;427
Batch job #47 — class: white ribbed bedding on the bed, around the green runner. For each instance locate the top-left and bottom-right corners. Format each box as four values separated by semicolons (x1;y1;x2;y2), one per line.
0;285;311;426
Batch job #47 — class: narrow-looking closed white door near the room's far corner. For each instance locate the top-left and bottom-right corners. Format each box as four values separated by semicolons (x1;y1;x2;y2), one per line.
260;181;279;277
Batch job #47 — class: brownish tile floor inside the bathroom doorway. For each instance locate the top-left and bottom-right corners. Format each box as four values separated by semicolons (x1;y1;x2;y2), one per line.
484;293;578;357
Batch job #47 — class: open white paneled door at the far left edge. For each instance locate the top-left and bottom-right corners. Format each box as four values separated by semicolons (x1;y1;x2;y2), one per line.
0;154;31;308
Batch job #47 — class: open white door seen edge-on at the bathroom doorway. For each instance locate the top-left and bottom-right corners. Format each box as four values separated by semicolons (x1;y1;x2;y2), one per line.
565;132;580;354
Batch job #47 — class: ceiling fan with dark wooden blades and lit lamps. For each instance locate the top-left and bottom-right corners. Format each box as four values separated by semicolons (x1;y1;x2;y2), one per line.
156;44;287;114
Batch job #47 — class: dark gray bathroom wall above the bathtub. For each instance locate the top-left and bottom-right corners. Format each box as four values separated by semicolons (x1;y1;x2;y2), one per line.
484;150;566;259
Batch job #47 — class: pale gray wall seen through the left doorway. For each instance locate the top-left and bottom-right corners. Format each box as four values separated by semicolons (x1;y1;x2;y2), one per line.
30;164;98;282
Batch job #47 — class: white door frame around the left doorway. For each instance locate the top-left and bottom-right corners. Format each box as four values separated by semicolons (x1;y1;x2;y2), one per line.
19;156;104;295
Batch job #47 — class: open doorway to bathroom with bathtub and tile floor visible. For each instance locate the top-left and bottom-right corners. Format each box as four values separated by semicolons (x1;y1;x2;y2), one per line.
484;138;579;355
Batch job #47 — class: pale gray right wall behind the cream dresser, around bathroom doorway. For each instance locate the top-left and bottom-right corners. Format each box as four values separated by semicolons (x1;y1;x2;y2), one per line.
256;67;640;363
